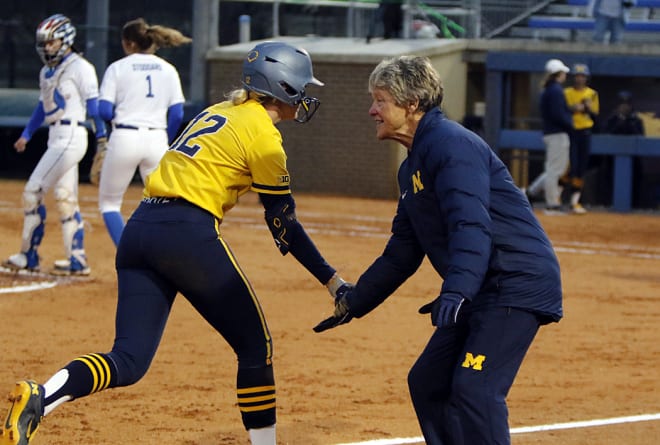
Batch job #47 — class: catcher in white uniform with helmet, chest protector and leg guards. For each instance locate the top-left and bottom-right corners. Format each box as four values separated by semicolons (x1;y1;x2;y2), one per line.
3;14;107;275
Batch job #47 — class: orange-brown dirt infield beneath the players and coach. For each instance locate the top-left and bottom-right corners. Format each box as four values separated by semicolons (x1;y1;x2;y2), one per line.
0;181;660;445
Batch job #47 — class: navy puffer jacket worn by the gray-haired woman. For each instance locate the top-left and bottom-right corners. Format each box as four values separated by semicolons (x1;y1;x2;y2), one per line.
348;108;562;322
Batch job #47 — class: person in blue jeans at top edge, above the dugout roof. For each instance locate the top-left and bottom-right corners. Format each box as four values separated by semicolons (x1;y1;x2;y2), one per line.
587;0;637;43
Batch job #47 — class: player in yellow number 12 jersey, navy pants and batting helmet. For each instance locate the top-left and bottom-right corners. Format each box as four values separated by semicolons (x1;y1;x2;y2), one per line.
0;42;351;445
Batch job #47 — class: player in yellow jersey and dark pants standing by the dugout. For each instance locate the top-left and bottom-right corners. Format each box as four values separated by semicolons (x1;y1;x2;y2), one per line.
564;63;600;215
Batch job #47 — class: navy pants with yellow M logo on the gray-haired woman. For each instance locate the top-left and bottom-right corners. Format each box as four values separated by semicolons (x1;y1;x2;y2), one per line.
408;308;540;445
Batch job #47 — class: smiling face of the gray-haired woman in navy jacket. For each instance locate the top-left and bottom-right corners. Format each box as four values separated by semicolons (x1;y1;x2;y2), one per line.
369;88;424;149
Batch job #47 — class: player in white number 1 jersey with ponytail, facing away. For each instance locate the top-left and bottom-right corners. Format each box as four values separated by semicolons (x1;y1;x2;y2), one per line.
90;18;192;246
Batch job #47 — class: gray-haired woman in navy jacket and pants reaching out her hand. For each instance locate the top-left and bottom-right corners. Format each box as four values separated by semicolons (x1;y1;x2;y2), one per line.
314;56;562;445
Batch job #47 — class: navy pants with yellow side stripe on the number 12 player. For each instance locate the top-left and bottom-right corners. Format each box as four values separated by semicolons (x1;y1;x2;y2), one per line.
108;198;275;429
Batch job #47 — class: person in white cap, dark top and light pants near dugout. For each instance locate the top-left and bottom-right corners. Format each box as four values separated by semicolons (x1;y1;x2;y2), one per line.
525;59;573;215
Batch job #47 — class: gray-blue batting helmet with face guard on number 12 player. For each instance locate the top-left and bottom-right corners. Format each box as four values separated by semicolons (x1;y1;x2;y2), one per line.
242;42;323;122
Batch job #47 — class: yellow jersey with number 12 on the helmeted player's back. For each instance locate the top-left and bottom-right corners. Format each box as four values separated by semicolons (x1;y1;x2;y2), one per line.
143;100;291;220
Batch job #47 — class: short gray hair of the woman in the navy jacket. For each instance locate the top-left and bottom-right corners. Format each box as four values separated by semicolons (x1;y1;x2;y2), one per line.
369;56;443;112
